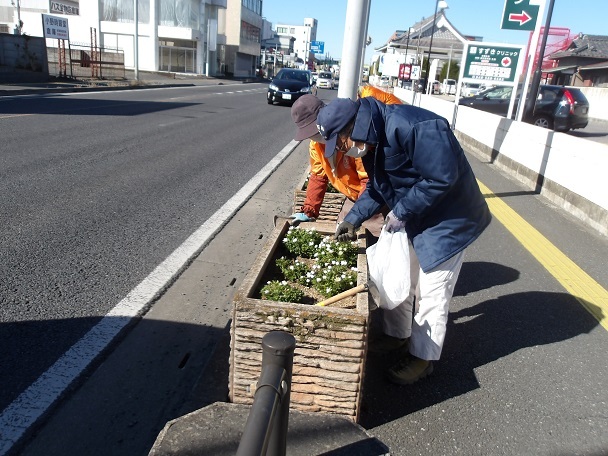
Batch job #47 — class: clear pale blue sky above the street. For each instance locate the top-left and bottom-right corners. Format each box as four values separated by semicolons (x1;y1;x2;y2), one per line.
262;0;608;63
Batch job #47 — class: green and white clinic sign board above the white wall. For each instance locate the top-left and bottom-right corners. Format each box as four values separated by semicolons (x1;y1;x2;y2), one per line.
461;42;522;83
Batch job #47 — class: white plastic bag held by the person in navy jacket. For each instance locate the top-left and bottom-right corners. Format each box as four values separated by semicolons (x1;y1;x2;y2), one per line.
365;227;411;310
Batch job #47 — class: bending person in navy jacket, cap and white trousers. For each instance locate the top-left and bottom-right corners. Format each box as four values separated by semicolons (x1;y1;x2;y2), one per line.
317;97;491;384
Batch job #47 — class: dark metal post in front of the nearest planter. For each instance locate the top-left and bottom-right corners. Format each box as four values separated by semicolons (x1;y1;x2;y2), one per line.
236;331;296;456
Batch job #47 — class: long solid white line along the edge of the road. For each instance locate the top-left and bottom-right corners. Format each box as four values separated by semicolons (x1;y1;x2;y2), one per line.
0;141;299;455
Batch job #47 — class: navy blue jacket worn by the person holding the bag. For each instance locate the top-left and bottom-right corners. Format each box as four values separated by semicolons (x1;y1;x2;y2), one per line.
344;97;491;272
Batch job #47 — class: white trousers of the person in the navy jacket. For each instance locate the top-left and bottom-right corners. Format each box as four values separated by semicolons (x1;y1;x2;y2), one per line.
382;242;464;360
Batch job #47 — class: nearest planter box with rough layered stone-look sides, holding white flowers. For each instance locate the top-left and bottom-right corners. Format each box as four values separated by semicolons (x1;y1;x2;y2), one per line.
229;222;370;421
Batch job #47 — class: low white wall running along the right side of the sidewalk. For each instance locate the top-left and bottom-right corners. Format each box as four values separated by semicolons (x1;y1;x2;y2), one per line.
395;88;608;235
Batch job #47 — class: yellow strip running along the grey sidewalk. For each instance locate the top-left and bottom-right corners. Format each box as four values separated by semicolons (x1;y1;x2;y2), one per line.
477;181;608;330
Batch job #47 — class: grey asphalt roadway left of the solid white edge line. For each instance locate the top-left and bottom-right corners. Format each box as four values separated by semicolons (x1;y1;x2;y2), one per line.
0;84;332;424
